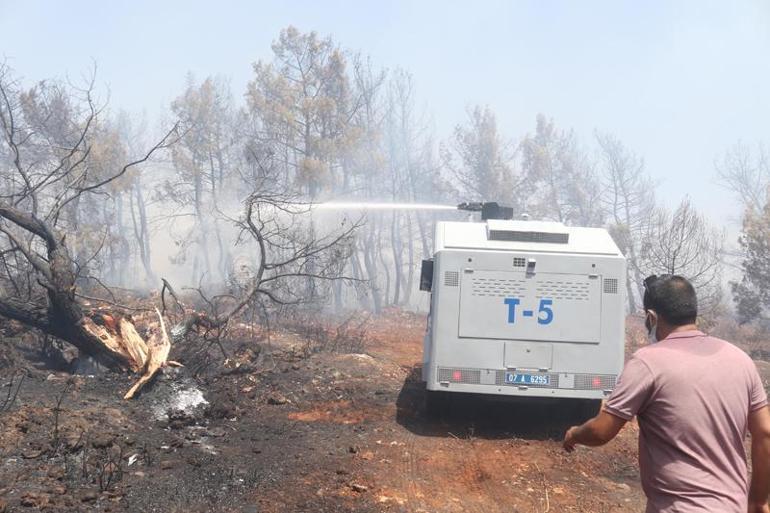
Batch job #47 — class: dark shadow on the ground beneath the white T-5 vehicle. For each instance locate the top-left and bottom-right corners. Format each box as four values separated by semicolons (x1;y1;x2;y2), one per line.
396;366;599;440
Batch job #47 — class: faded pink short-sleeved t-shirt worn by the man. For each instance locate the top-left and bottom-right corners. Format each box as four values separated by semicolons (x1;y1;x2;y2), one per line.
604;331;767;513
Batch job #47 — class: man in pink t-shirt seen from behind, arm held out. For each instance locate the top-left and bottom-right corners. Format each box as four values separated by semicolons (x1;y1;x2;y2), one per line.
564;275;770;513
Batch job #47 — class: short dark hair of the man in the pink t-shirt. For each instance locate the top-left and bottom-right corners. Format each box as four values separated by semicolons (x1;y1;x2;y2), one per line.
644;274;698;326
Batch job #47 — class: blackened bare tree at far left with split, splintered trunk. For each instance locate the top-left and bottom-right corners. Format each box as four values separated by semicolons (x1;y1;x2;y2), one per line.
0;65;177;371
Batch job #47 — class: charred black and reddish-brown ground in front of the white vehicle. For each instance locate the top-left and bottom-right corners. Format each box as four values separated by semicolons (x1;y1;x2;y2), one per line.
0;312;664;513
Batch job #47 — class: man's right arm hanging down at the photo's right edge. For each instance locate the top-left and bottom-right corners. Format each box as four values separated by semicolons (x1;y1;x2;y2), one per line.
749;406;770;513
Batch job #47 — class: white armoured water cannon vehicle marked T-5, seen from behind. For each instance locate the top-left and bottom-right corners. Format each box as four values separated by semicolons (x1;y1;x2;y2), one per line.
420;203;626;407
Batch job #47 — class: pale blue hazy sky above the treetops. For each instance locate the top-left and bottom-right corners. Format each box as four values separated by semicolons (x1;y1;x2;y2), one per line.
0;0;770;232
